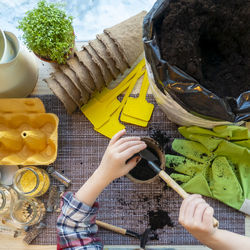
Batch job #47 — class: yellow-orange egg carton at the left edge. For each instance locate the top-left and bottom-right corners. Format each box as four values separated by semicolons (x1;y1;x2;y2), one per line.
0;98;59;165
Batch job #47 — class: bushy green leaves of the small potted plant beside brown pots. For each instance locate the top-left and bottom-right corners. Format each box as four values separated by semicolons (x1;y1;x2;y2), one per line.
18;0;75;63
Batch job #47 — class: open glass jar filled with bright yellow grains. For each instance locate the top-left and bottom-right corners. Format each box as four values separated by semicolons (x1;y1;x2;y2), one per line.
13;166;50;197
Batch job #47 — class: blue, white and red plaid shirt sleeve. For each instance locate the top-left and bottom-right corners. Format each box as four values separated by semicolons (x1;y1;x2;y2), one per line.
57;192;103;250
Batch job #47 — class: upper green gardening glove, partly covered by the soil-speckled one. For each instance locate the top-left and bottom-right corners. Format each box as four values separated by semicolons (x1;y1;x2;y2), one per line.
179;125;250;213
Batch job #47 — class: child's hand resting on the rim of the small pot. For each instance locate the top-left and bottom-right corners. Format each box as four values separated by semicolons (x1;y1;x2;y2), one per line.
96;129;147;182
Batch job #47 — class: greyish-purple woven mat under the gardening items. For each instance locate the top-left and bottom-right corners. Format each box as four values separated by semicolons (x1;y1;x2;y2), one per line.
33;95;245;245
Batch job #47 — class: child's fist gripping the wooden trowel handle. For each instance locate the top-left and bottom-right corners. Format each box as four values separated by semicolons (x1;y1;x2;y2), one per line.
179;194;217;242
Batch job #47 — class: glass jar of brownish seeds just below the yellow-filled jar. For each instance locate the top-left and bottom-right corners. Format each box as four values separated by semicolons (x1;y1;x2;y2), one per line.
11;197;45;228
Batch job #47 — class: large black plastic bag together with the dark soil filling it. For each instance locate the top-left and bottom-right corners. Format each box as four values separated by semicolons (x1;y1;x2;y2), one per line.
143;0;250;122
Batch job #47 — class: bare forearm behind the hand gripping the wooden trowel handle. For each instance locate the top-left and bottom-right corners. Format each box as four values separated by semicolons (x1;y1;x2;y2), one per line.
200;229;250;250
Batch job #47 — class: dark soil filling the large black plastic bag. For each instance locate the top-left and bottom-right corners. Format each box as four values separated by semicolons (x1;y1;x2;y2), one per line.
157;0;250;97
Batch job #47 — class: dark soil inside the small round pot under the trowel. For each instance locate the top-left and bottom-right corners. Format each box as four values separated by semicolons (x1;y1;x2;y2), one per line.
129;148;161;181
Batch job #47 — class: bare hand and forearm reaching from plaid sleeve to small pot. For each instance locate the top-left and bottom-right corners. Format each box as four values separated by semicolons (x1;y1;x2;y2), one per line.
75;129;147;207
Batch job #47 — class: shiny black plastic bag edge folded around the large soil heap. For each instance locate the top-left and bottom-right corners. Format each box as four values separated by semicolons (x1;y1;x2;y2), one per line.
143;0;250;122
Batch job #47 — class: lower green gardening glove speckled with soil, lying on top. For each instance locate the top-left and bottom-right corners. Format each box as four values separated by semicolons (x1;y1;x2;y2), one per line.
166;155;244;211
